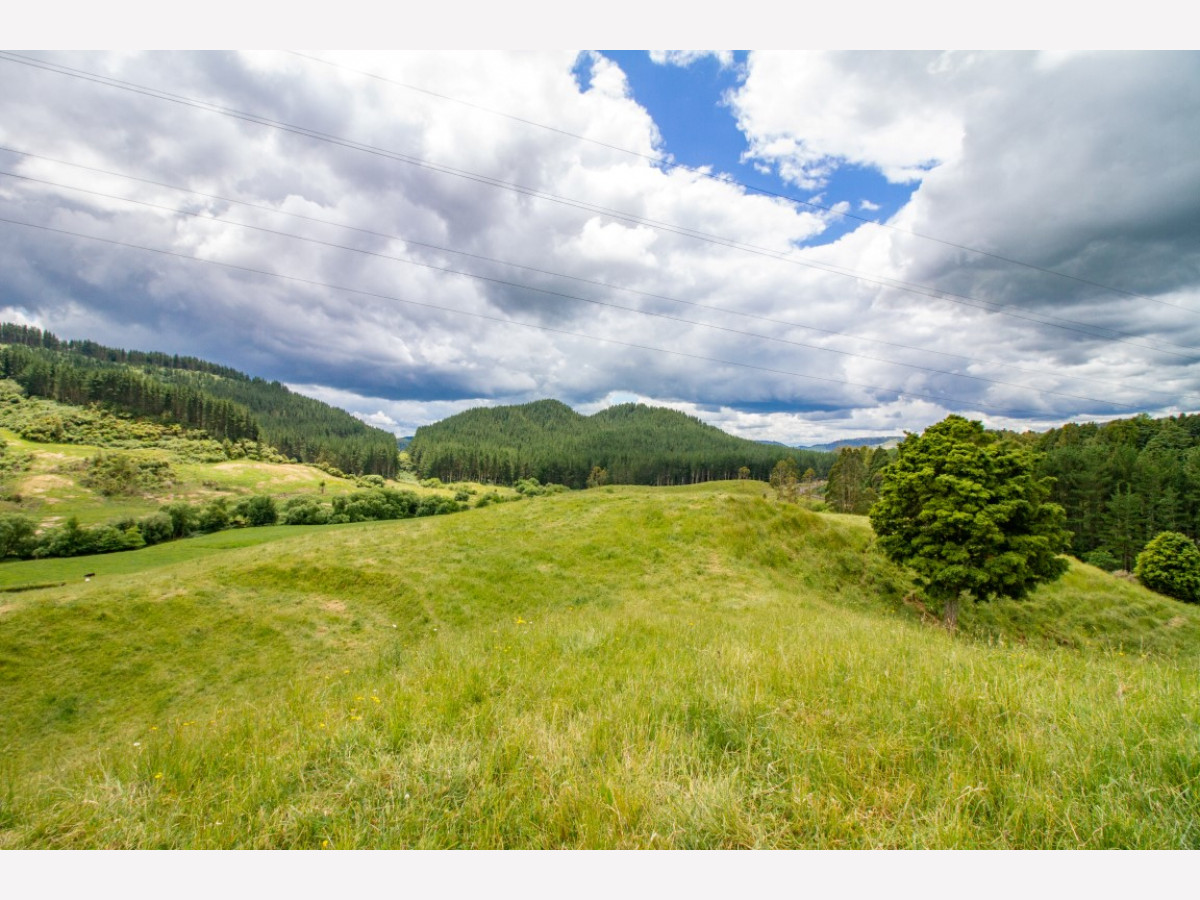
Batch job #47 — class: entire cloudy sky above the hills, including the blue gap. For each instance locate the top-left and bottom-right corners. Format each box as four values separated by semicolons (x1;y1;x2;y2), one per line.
0;49;1200;445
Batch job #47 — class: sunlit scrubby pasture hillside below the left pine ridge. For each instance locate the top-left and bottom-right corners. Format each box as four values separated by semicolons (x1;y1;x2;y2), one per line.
0;393;487;578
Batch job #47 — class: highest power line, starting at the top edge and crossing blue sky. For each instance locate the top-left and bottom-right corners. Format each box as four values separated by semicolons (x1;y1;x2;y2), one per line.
287;50;1200;314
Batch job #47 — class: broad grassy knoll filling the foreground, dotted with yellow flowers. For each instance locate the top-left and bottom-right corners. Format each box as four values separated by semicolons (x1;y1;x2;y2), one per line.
0;484;1200;848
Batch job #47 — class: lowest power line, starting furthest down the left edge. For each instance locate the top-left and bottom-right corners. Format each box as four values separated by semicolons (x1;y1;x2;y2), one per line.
0;216;1132;418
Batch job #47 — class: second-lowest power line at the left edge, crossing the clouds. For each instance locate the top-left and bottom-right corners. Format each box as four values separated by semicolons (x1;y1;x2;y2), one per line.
0;170;1156;409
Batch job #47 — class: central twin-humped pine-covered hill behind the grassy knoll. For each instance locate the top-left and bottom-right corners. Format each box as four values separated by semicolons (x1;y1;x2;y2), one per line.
408;400;834;487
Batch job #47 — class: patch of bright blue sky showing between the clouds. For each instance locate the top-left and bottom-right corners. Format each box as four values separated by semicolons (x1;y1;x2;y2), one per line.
574;50;917;246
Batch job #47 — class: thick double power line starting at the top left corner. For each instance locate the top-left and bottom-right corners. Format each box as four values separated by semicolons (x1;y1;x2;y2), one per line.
0;52;1200;359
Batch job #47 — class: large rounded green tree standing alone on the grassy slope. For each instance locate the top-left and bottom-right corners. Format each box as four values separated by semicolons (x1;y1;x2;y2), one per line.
870;415;1070;629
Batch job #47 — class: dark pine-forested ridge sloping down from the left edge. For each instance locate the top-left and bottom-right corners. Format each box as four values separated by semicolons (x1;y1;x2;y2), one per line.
0;323;397;476
